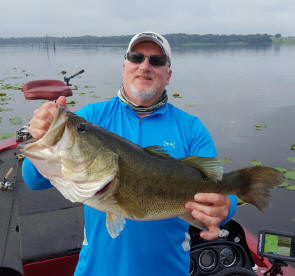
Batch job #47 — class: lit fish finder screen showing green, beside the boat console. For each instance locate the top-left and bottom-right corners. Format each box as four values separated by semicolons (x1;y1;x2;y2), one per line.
264;234;295;257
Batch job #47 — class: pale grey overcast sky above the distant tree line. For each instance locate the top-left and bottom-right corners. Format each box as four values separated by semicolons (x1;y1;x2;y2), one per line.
0;0;295;37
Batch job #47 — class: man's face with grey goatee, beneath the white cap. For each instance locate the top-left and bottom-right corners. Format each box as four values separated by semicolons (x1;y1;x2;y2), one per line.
123;41;172;106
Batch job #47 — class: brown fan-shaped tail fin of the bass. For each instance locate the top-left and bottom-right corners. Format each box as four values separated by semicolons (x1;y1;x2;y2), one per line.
229;166;283;211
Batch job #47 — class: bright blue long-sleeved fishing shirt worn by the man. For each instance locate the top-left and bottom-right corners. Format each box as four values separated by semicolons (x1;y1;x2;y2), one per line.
23;97;237;276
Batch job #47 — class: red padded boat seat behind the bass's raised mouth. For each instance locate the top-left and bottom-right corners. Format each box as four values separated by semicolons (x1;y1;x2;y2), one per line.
23;80;73;100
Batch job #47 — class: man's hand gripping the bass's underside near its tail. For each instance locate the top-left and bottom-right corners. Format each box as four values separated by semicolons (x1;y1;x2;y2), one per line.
185;193;231;240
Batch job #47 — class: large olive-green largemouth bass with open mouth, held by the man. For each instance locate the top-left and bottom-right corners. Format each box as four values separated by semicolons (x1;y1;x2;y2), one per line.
19;106;282;238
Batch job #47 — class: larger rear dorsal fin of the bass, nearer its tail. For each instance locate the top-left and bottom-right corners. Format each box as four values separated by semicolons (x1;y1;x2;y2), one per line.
180;156;223;181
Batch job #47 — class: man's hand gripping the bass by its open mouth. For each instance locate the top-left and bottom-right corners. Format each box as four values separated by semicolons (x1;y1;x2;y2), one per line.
29;96;66;139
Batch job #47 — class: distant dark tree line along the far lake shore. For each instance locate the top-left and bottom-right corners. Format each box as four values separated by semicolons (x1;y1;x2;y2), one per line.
0;33;272;46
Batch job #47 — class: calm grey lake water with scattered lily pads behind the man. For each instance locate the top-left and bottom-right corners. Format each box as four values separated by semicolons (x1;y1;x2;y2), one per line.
0;46;295;236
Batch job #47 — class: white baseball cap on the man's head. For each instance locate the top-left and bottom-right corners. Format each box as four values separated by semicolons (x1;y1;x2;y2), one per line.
126;31;171;65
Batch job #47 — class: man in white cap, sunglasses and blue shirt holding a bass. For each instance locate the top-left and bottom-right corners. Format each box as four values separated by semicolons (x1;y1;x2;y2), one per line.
23;32;236;276
